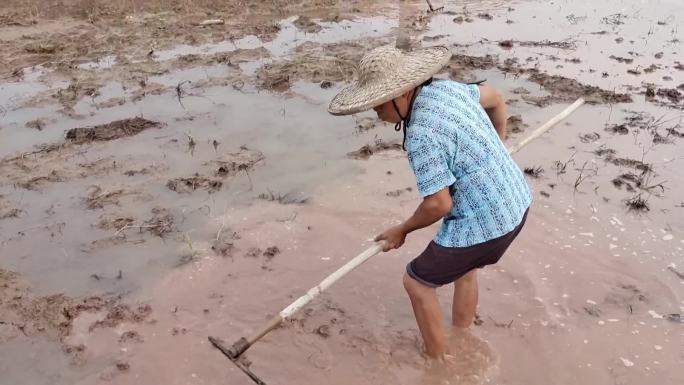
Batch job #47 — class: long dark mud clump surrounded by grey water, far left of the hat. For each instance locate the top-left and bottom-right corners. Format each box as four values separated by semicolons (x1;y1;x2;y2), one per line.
66;117;161;144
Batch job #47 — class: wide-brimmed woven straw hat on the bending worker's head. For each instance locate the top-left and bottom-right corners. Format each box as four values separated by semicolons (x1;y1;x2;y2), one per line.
328;46;451;115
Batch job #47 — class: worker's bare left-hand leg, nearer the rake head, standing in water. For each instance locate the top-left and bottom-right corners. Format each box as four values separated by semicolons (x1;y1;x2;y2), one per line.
404;273;446;359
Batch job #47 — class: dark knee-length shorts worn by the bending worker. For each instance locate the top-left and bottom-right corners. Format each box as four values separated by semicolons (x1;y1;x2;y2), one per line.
406;209;529;287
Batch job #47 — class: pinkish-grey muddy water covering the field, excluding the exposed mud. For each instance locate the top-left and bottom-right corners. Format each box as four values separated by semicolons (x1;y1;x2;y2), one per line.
0;1;684;384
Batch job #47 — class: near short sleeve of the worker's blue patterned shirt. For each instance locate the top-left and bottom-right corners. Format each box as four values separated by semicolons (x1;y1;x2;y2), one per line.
406;131;456;198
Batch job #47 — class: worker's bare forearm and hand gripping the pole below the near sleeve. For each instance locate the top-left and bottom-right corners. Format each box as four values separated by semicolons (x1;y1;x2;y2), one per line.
375;187;453;251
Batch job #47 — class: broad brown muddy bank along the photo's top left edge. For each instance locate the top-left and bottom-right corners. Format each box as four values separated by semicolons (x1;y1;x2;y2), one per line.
0;0;384;74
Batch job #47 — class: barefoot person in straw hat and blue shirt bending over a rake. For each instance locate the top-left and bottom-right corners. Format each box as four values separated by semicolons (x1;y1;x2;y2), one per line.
328;47;532;358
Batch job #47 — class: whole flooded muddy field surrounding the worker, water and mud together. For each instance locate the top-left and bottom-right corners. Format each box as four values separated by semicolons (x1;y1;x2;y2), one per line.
0;0;684;385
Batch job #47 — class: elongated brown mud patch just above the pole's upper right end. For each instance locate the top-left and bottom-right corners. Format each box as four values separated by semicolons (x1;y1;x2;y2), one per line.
529;72;632;104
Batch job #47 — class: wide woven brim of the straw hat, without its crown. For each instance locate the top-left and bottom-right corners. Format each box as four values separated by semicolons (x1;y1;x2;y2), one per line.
328;46;451;115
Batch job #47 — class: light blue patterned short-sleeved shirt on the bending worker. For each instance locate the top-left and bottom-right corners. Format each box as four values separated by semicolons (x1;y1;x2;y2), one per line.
406;80;532;247
